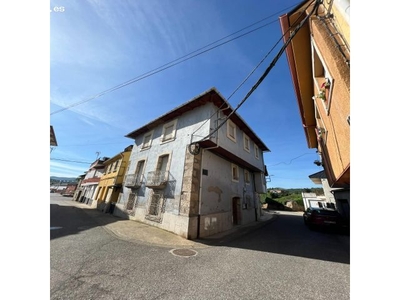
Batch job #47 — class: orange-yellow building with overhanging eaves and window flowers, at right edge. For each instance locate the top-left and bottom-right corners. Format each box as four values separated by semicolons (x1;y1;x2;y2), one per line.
280;0;350;215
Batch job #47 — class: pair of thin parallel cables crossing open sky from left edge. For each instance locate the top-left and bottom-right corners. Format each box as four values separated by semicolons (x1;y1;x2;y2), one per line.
50;1;302;115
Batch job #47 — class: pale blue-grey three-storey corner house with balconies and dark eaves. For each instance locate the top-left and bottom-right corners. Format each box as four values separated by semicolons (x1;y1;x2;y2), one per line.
114;88;270;239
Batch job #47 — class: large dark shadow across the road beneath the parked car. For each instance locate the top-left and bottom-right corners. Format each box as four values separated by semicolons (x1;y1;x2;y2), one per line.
197;213;350;264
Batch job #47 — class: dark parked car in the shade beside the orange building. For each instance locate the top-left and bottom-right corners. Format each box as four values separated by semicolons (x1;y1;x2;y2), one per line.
303;207;348;230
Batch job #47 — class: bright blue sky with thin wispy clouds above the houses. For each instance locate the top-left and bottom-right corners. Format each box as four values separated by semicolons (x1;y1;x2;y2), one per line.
50;0;322;188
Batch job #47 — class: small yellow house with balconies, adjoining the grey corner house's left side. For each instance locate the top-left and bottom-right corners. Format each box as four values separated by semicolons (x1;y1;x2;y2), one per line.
92;145;133;212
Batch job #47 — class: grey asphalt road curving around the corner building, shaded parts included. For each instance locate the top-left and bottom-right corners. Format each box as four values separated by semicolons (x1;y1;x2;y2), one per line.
50;197;350;300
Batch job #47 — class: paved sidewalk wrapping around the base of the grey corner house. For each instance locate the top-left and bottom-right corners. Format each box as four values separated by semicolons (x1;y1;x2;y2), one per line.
71;201;276;248
